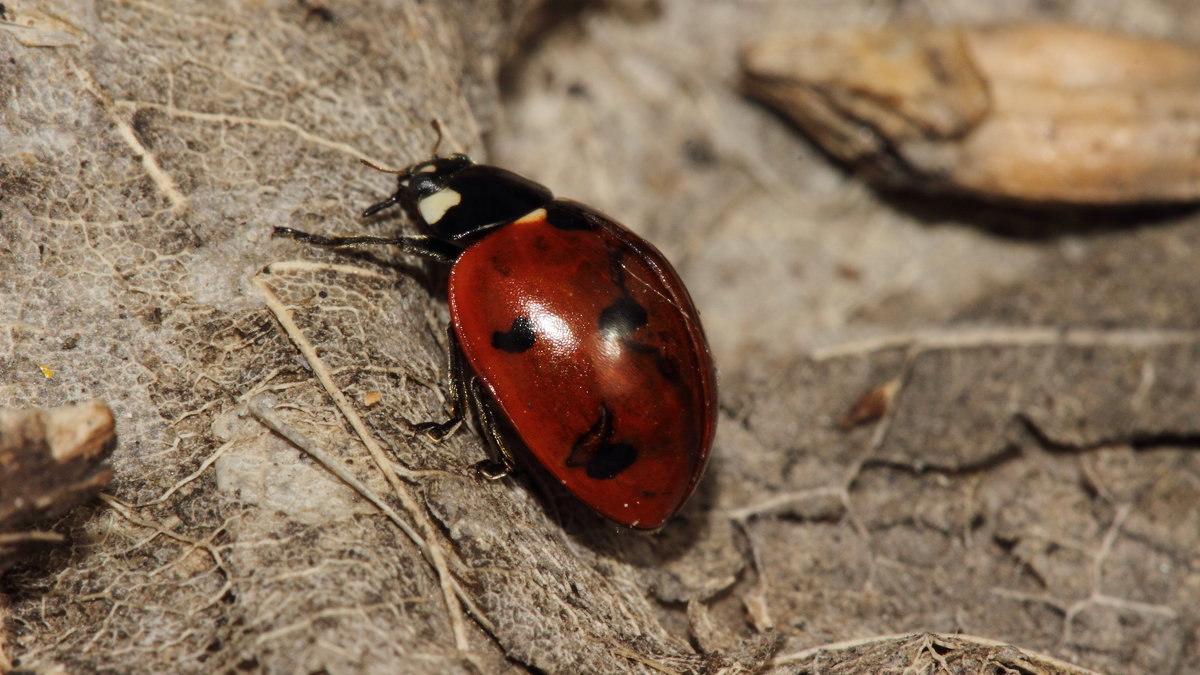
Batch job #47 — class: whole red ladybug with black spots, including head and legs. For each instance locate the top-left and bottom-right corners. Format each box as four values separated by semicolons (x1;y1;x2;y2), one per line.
275;148;716;530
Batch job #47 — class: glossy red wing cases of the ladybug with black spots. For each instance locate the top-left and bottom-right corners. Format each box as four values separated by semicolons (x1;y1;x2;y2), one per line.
450;202;715;528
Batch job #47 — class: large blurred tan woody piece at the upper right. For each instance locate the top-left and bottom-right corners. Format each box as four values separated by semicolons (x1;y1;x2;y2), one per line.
743;24;1200;204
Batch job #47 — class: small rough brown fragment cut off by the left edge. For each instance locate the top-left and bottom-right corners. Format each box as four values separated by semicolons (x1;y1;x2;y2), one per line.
0;401;116;572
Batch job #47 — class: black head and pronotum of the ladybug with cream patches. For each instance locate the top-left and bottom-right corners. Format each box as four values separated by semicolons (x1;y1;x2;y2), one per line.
362;155;553;246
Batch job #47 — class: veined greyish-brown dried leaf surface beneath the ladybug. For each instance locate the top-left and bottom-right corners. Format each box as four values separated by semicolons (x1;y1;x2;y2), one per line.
0;0;1200;673
